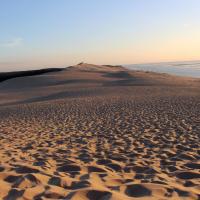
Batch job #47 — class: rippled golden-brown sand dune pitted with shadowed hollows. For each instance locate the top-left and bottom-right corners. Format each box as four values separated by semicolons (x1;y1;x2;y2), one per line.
0;64;200;200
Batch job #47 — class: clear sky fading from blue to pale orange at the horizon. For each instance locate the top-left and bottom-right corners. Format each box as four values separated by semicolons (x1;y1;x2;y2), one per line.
0;0;200;71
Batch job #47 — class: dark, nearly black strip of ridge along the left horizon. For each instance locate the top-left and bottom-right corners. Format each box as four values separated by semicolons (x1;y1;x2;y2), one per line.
0;68;64;82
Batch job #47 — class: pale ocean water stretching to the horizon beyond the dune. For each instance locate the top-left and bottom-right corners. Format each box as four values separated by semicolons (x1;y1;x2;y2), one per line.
124;61;200;78
